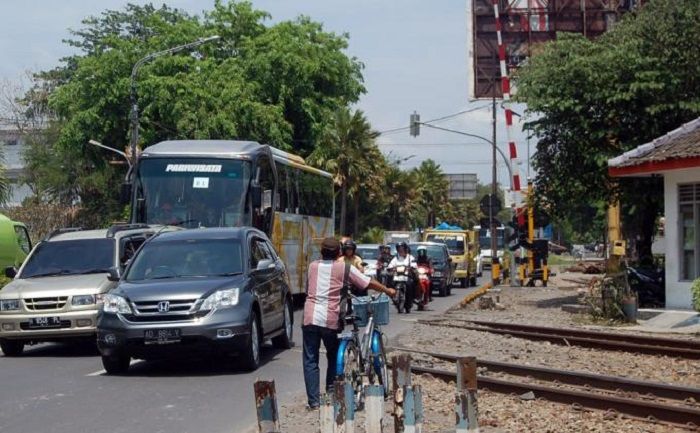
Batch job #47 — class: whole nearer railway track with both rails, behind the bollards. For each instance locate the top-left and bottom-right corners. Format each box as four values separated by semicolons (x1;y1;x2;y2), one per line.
390;347;700;430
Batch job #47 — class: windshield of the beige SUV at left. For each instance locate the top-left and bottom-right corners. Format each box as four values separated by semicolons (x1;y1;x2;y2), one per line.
20;238;115;278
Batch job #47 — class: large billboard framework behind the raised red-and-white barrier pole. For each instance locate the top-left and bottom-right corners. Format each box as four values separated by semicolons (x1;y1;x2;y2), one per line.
467;0;643;99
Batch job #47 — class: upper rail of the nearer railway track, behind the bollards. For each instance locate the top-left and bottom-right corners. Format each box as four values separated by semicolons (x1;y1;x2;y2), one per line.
388;347;700;402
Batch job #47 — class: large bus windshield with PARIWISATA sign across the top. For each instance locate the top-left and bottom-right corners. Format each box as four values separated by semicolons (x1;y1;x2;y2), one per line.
135;158;251;228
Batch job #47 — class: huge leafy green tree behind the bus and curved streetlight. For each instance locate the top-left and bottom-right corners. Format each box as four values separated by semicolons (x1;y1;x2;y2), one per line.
30;1;364;224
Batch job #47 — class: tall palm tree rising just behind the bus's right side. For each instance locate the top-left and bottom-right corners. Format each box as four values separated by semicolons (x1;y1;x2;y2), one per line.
309;107;379;234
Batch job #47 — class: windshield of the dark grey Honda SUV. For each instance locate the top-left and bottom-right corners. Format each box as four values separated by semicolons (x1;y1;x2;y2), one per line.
126;239;243;281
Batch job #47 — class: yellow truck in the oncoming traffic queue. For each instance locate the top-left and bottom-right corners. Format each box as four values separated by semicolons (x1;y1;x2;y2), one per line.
423;225;479;287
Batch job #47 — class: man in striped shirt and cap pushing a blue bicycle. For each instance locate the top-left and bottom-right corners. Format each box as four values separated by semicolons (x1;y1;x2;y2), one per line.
302;238;395;409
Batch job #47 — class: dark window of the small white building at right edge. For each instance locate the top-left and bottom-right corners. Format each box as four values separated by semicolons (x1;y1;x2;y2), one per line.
678;183;700;281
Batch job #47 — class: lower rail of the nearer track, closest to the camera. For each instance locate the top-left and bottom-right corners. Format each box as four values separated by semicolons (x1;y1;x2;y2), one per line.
404;366;700;430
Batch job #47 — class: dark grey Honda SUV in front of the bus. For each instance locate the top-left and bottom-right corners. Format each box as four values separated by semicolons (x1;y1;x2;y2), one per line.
97;227;293;374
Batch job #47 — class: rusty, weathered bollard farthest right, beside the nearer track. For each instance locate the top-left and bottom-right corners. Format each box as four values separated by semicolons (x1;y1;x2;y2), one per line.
455;356;479;433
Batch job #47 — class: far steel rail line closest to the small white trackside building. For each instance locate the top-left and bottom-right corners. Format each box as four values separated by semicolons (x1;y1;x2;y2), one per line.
418;320;700;359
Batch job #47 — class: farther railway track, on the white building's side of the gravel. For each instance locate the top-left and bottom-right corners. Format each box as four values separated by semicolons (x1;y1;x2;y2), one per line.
418;318;700;359
